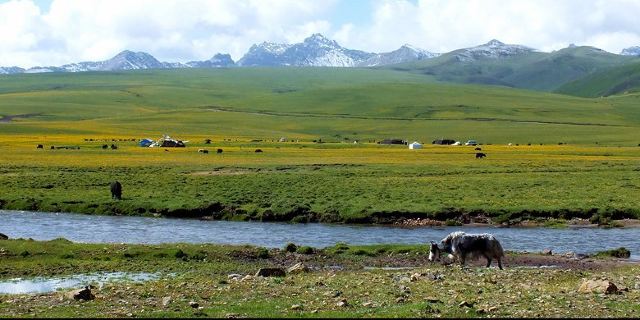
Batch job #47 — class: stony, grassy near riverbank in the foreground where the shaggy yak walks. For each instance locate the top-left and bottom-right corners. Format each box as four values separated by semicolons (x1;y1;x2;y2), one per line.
0;239;640;318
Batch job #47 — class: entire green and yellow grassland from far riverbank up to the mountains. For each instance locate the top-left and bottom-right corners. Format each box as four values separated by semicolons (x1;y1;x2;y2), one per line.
0;68;640;222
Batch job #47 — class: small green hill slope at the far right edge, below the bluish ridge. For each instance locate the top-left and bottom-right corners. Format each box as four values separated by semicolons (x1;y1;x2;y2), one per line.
556;62;640;97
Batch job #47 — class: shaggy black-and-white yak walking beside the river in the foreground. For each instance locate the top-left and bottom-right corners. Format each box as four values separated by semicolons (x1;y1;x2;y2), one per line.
429;231;504;270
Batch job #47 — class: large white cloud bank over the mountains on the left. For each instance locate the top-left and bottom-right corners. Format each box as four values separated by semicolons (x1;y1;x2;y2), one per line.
0;0;335;67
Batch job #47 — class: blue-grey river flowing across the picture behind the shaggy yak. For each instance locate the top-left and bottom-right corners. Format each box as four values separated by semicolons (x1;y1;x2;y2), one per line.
0;210;640;260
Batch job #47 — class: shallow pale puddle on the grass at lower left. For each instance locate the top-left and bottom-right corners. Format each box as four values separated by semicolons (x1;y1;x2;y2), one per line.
0;272;169;294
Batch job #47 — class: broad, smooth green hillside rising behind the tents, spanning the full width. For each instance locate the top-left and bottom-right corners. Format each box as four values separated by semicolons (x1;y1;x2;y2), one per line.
0;68;640;143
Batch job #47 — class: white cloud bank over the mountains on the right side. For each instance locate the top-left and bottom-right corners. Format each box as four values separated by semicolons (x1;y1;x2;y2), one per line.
338;0;640;53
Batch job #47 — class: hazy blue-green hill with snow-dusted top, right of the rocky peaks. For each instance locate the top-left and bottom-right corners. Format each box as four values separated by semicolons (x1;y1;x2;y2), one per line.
388;47;640;91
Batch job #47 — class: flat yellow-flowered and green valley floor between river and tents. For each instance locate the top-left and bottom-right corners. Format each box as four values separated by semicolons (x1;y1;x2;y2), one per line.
0;137;640;226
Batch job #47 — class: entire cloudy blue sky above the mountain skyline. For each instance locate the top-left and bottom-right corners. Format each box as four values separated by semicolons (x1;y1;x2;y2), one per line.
0;0;640;67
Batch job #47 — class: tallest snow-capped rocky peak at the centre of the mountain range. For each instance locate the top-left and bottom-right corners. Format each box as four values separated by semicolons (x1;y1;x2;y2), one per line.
238;33;374;67
